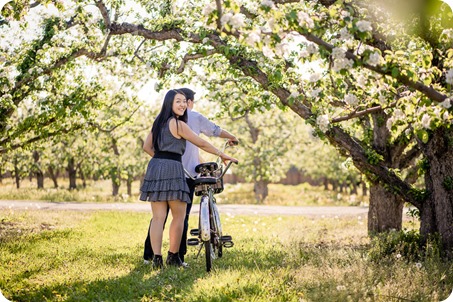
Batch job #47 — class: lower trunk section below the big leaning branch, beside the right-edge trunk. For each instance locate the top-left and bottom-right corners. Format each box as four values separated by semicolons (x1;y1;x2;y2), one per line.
368;184;404;234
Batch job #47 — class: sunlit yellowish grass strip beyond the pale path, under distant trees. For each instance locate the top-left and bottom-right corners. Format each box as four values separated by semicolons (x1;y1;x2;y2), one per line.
0;178;368;206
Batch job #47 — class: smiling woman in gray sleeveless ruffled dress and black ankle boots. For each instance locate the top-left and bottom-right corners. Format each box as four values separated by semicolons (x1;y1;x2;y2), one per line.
140;89;237;268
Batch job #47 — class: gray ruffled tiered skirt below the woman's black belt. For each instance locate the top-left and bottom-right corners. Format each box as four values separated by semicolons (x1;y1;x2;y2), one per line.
140;158;191;203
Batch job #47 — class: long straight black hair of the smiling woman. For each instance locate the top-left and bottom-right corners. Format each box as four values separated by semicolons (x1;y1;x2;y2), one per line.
151;89;187;152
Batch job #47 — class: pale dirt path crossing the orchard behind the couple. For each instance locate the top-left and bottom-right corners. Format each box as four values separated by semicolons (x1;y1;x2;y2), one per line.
0;200;368;218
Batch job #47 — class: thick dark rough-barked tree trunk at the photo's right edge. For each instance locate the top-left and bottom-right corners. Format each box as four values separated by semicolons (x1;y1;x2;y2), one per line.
420;128;453;256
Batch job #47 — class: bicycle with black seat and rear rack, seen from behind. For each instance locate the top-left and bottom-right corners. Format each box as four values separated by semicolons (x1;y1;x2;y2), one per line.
186;142;237;272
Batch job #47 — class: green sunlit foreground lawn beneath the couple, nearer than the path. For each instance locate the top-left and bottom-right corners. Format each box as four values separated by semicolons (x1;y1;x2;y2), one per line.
0;210;453;301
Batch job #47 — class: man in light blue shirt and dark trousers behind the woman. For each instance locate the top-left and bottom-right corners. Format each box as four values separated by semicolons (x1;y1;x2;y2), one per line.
143;88;238;266
